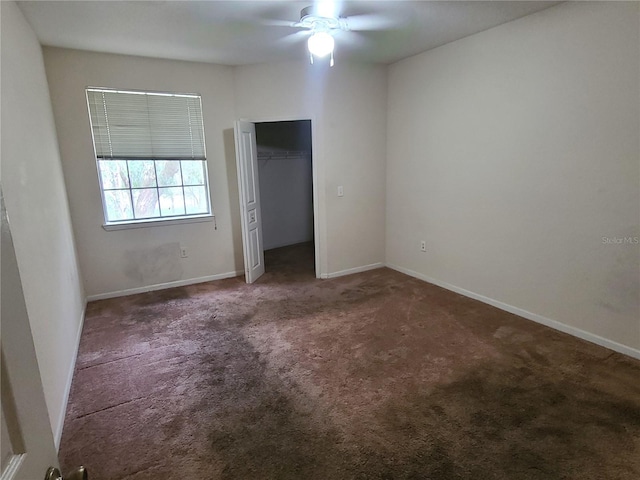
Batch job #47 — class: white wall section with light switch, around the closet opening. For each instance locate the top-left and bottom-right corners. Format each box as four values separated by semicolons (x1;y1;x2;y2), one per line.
234;59;386;276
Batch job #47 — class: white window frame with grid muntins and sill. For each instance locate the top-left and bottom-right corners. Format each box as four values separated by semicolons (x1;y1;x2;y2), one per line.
85;86;215;231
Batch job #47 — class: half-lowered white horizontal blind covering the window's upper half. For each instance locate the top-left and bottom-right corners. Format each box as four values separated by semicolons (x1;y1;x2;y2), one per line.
87;88;206;160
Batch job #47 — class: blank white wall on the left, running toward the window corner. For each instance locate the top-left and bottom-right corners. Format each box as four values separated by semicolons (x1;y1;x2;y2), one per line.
0;2;84;441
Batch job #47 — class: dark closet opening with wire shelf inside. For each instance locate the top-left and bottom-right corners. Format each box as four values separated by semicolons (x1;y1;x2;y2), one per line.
255;120;315;275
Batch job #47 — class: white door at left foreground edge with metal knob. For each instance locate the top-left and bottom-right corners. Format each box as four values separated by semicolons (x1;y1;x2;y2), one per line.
0;190;58;480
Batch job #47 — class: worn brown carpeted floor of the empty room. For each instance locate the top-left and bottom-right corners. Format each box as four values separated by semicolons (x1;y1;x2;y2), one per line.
60;245;640;480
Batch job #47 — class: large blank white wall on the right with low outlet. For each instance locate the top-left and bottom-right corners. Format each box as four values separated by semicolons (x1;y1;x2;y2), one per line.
386;2;640;352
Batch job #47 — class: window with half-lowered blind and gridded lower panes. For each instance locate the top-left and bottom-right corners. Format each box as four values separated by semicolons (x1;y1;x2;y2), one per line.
87;88;211;226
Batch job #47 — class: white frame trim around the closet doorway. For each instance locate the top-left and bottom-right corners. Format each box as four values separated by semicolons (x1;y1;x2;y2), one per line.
238;115;326;278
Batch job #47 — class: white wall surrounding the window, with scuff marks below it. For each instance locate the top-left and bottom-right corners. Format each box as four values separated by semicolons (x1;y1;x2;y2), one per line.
44;48;243;296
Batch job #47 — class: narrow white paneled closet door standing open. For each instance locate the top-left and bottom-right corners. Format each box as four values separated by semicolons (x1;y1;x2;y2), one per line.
235;120;264;283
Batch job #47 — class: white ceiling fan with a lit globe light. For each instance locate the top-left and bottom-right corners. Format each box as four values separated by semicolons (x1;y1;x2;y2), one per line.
283;2;394;67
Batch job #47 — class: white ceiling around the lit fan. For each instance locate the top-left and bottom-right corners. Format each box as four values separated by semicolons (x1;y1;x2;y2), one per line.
18;0;560;65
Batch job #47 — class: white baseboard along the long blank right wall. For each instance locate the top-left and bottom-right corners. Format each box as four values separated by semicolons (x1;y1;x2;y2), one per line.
387;264;640;360
